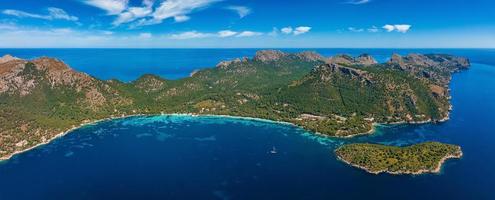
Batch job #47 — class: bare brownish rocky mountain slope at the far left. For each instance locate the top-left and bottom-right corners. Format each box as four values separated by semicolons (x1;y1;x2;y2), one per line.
0;56;110;107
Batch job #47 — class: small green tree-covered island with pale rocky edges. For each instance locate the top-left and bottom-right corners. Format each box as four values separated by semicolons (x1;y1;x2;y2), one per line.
335;142;462;174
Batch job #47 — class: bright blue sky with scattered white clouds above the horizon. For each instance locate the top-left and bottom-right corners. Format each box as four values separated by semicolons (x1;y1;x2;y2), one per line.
0;0;495;48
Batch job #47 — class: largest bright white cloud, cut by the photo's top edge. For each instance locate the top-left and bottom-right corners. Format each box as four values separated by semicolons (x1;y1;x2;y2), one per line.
134;0;221;26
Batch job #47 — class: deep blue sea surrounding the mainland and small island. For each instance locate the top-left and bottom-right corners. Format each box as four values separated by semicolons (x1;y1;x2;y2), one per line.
0;49;495;200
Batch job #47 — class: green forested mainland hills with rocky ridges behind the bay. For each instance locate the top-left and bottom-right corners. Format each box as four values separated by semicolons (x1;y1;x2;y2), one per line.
0;50;469;158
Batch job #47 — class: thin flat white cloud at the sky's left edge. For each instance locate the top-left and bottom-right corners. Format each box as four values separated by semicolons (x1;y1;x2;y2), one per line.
2;7;79;21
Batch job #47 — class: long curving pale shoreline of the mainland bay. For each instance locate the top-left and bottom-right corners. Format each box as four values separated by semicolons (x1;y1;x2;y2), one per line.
0;113;449;162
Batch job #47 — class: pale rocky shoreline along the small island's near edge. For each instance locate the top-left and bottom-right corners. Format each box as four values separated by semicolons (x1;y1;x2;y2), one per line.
334;147;464;175
